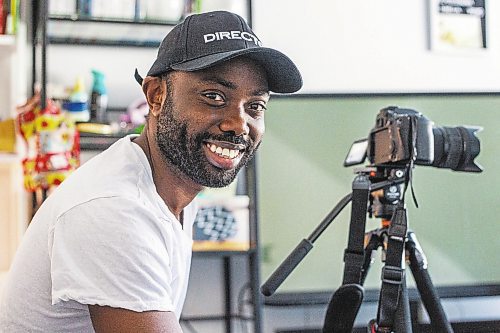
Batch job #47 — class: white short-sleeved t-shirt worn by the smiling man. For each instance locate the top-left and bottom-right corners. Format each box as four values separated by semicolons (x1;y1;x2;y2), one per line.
0;136;196;333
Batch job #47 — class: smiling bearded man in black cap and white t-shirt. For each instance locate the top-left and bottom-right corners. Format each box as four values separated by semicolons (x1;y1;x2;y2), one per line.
0;11;302;333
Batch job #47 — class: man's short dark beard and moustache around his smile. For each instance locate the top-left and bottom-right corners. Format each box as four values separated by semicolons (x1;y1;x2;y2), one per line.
156;94;260;187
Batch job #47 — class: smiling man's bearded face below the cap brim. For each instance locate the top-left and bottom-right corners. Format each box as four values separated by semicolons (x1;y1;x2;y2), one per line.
156;58;269;187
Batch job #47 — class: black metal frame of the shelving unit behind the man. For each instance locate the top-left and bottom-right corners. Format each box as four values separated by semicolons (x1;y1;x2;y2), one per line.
31;0;263;333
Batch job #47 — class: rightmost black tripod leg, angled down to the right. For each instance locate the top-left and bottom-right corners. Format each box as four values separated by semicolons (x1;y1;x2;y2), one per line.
406;232;453;333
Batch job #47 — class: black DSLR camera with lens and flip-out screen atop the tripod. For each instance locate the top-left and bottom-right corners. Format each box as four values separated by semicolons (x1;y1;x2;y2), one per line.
344;106;483;172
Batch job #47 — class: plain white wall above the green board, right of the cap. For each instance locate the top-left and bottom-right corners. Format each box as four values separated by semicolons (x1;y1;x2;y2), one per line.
253;0;500;93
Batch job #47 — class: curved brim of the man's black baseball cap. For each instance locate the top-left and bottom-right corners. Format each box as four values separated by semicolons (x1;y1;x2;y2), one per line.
164;47;302;93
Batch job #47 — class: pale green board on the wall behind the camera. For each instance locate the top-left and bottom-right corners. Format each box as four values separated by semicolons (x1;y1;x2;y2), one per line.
258;95;500;292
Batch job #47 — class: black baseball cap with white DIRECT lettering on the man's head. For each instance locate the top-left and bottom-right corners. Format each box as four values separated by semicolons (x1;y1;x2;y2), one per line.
135;11;302;93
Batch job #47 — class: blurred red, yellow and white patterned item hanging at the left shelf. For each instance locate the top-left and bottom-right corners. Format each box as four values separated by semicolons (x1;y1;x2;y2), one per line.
17;96;80;192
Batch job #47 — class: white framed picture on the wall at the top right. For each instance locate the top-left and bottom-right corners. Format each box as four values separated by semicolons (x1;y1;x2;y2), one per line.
429;0;487;53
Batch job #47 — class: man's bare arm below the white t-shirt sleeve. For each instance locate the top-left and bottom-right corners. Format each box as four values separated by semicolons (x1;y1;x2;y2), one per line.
89;305;182;333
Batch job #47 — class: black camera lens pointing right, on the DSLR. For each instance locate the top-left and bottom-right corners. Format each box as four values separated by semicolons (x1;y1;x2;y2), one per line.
432;126;482;172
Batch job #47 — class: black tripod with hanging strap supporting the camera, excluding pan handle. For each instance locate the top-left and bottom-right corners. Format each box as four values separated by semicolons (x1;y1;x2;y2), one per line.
323;168;453;333
